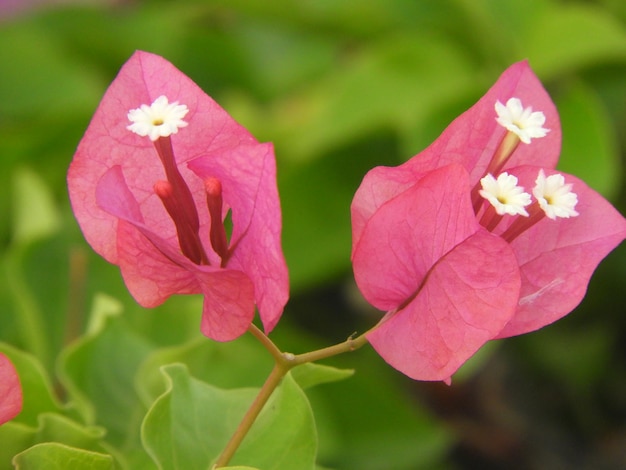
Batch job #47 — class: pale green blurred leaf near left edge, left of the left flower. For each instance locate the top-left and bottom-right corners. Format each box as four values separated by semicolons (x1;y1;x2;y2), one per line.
13;168;61;245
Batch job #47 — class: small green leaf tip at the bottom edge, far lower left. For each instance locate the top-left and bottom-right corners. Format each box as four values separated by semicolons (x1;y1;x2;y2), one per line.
14;442;114;470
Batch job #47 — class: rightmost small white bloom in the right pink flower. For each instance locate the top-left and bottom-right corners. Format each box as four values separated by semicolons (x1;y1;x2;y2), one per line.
533;170;578;220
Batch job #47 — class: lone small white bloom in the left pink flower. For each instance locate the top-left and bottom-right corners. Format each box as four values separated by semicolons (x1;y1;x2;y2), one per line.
126;95;189;142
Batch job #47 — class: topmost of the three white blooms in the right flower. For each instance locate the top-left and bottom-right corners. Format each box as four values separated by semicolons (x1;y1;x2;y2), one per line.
495;98;550;144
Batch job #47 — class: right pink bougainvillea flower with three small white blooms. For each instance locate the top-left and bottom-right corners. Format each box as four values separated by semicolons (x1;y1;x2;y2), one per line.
352;62;626;380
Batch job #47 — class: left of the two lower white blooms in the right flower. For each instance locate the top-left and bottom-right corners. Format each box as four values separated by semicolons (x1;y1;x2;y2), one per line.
479;172;531;217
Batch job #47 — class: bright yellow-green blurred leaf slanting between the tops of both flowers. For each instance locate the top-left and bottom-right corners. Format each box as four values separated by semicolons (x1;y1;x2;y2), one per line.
274;32;473;161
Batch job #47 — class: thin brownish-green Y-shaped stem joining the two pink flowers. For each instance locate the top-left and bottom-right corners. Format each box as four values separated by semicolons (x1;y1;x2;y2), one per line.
213;325;367;469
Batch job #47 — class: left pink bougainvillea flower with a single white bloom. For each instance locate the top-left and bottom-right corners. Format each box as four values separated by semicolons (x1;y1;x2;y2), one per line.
68;52;288;341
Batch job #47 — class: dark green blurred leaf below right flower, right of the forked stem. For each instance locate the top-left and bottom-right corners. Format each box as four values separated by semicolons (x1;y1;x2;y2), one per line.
308;347;454;470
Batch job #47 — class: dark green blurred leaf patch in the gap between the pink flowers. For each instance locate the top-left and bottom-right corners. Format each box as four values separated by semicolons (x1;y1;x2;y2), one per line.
278;134;396;296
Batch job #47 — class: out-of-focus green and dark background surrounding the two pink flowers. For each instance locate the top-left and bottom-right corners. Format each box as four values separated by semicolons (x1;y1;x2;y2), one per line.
0;0;626;470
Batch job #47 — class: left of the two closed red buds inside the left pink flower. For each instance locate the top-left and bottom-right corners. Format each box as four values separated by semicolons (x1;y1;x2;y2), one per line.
154;181;209;264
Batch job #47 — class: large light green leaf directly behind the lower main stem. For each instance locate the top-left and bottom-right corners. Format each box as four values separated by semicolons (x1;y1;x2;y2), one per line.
142;364;317;470
